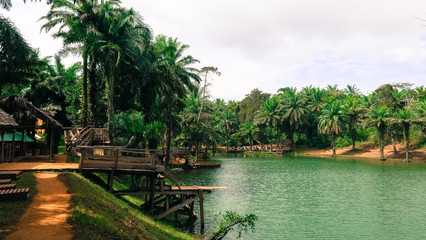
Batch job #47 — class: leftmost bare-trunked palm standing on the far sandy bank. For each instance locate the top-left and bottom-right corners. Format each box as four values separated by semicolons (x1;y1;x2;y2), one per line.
318;101;347;156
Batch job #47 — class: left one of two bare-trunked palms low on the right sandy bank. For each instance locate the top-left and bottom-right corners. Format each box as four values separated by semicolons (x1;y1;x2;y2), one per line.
365;105;390;160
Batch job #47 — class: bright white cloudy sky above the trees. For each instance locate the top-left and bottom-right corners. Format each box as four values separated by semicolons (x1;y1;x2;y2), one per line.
0;0;426;101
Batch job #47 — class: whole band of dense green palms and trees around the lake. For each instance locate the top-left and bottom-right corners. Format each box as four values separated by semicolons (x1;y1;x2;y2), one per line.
0;0;426;162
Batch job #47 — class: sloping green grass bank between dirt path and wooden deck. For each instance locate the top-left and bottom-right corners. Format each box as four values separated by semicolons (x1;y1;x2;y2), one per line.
59;173;193;239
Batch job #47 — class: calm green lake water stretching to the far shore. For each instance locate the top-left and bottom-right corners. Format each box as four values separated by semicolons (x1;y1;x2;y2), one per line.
172;156;426;239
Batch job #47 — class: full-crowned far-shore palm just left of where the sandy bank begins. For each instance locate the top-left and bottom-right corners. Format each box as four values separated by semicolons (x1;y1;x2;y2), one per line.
280;88;308;144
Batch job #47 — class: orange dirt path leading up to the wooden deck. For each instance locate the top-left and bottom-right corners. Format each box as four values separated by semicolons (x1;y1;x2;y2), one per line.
6;173;72;240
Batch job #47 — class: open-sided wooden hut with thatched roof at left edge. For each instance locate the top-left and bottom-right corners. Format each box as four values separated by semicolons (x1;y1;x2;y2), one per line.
0;95;62;160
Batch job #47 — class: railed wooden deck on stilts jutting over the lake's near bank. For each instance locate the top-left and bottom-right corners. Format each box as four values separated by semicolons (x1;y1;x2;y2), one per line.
77;146;225;225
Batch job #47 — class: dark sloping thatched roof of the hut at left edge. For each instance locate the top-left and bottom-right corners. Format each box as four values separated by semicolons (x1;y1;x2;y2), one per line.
0;95;62;128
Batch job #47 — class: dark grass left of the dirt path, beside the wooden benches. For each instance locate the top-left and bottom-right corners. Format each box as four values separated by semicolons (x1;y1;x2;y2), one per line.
0;173;37;239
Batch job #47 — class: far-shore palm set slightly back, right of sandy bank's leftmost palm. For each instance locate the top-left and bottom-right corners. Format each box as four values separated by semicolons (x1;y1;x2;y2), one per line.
344;95;365;150
